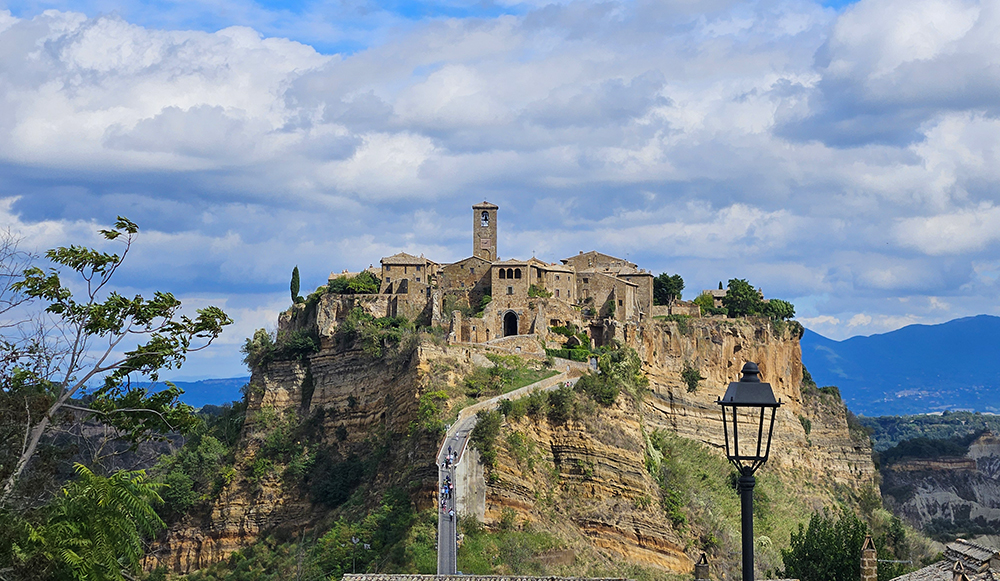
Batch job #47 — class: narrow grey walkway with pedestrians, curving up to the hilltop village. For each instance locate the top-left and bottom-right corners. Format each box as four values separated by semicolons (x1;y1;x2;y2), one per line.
437;370;580;575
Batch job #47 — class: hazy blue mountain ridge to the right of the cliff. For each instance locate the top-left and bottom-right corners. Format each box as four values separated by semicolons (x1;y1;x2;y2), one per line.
802;315;1000;416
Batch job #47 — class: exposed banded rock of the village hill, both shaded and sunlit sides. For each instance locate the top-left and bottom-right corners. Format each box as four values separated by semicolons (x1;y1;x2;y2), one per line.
147;314;875;573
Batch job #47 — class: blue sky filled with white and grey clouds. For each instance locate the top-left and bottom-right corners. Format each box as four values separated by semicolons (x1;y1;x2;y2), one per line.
0;0;1000;380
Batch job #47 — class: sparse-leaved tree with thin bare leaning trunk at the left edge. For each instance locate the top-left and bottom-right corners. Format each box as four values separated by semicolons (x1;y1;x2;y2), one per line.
0;216;232;507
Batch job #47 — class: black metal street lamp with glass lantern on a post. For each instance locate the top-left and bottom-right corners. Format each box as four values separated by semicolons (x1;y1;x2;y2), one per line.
716;361;781;581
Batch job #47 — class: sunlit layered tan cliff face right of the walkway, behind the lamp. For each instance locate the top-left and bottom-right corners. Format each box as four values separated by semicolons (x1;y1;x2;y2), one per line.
476;319;876;573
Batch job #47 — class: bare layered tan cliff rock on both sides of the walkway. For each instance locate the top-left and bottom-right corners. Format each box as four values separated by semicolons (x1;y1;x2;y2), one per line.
148;294;875;572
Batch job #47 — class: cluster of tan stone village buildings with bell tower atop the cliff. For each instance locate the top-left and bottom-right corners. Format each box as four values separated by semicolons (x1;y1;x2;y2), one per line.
379;201;672;344
